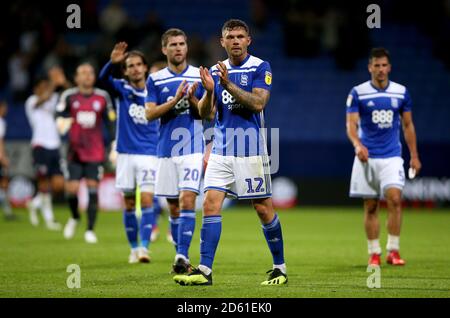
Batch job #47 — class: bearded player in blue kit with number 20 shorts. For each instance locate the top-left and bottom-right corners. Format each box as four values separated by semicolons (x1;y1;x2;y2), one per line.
145;29;204;273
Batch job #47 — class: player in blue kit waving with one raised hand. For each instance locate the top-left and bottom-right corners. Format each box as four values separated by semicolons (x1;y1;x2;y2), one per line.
99;42;158;263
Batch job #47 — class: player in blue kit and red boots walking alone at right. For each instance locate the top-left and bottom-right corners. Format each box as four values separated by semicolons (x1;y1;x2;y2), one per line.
347;48;421;266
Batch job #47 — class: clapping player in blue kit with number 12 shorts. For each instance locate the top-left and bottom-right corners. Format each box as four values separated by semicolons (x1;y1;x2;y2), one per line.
174;19;287;286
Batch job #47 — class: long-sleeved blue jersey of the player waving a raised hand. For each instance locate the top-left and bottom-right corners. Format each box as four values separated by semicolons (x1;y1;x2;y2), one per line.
99;62;159;156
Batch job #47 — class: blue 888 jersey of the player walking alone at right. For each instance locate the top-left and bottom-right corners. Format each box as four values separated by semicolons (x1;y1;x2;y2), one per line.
347;81;412;158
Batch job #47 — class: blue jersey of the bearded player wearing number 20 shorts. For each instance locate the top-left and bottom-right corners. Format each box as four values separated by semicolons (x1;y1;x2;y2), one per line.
146;65;204;158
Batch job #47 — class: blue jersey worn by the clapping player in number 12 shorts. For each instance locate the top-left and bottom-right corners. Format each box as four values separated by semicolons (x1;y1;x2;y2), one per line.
210;54;272;157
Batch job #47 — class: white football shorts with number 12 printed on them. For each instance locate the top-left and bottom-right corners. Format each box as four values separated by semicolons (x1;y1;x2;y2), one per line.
204;154;272;199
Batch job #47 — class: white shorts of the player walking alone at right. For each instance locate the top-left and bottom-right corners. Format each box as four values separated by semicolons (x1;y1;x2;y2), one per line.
350;156;405;199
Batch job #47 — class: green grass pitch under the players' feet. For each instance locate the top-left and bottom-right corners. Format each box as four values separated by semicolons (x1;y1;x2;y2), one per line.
0;206;450;298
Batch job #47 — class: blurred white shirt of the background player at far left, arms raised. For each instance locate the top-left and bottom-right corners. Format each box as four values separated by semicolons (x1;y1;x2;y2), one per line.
25;93;61;149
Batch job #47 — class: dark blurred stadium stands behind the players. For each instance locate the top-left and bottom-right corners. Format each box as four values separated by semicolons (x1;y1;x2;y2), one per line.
0;0;450;206
